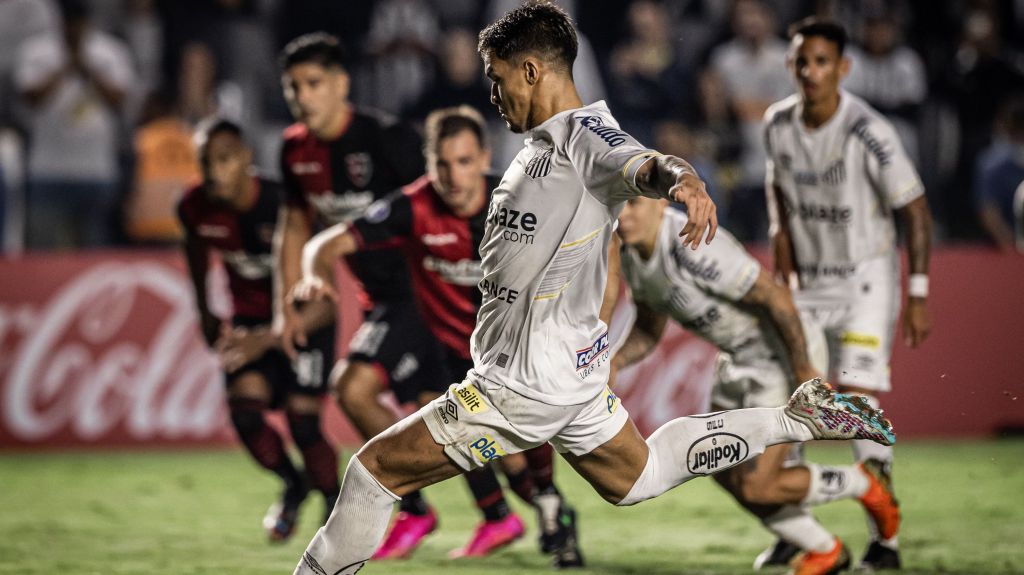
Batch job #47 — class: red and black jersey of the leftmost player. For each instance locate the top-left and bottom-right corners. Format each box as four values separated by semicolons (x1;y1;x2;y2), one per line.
178;178;283;322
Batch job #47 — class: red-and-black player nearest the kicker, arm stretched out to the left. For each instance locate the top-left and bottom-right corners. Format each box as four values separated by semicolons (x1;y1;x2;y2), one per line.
298;105;583;567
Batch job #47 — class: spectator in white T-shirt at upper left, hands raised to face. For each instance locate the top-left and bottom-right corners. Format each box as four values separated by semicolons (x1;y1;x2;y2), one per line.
14;0;134;249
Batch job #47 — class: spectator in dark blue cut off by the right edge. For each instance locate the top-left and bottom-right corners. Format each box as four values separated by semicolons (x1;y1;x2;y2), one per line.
974;96;1024;252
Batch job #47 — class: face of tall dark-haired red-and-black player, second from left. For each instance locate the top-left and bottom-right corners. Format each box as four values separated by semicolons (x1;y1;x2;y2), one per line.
282;62;348;135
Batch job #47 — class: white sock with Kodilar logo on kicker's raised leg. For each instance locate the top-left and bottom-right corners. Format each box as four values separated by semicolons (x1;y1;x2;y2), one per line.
618;407;813;505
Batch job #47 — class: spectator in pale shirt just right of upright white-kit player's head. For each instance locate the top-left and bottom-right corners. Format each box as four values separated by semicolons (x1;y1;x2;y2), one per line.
844;8;928;164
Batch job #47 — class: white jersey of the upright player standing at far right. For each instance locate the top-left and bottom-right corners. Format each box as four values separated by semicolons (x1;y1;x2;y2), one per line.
765;91;925;288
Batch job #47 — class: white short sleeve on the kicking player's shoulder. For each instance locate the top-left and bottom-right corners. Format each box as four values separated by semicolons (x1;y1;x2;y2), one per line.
567;110;659;205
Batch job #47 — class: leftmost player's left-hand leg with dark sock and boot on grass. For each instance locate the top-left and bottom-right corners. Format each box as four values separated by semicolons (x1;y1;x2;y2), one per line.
227;356;309;541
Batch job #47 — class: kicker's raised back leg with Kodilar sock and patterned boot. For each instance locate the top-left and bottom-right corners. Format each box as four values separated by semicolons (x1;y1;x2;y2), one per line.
552;380;895;505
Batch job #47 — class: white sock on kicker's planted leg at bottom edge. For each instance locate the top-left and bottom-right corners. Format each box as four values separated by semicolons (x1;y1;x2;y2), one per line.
294;457;401;575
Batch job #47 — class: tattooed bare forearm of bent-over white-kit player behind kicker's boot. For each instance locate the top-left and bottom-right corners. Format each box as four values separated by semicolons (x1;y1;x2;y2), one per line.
740;269;820;383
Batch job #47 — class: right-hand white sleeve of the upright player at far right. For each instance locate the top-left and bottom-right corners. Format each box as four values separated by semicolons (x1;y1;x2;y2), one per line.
853;119;925;210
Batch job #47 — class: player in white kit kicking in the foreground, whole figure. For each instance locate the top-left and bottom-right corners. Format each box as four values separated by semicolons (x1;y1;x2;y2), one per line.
295;5;895;575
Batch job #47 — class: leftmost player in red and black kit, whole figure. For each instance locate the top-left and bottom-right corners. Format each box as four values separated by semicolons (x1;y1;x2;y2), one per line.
178;120;338;540
